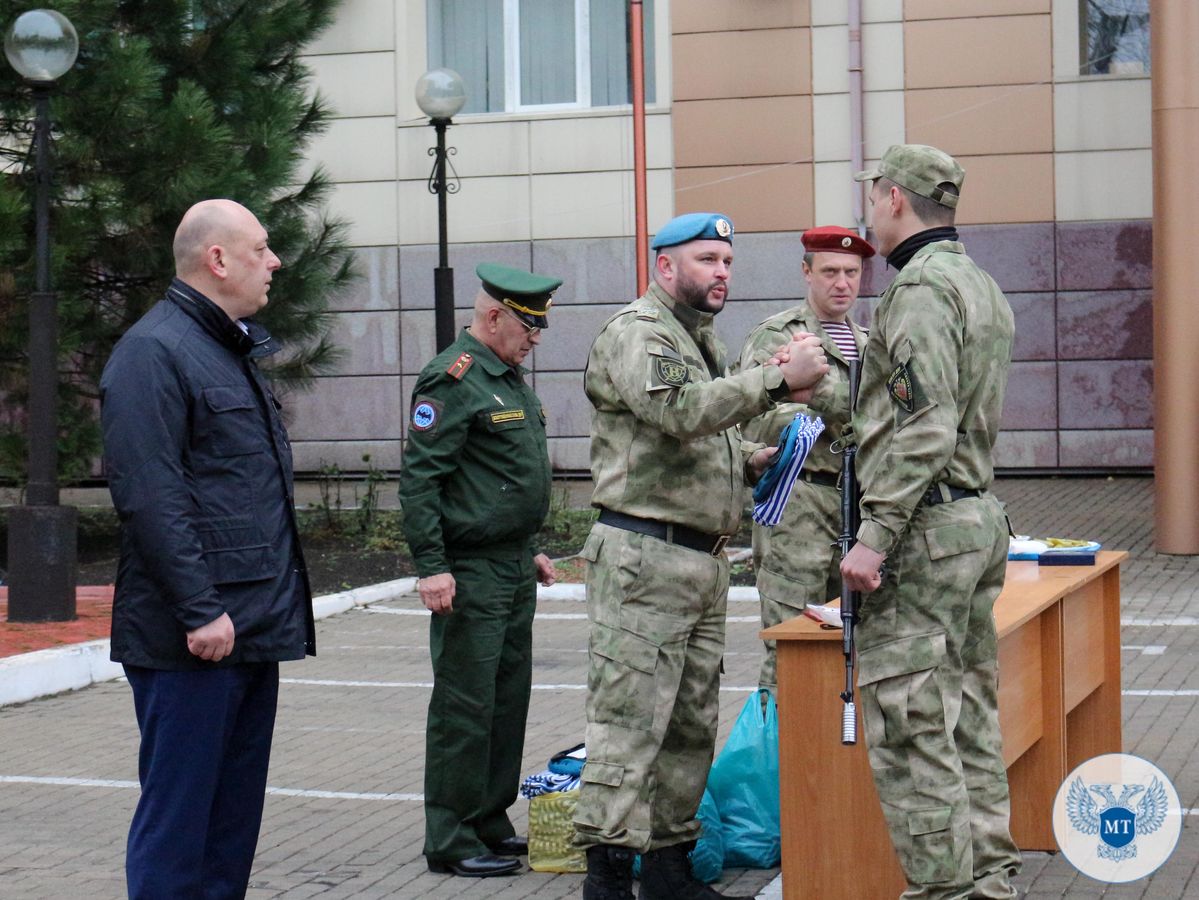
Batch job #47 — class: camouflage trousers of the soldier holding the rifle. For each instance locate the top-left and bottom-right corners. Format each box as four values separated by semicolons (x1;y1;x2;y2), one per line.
857;495;1020;900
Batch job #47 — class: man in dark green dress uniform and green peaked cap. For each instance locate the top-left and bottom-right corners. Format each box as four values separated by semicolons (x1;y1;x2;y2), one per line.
399;264;561;877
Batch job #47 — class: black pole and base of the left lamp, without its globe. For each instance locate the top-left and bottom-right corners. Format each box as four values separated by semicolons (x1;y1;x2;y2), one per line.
8;81;78;622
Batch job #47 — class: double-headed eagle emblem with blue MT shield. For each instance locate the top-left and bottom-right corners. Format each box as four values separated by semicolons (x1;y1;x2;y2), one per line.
1066;775;1169;863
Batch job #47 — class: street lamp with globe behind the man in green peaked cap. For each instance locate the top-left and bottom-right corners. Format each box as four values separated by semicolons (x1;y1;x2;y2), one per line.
416;68;466;352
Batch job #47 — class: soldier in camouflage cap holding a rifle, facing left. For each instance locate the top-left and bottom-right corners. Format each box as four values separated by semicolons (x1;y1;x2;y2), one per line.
842;144;1020;900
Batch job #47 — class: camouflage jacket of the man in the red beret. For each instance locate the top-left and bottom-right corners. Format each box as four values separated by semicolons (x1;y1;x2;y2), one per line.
739;303;866;475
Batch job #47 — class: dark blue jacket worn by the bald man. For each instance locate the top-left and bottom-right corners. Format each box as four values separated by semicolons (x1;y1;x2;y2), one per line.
100;278;315;669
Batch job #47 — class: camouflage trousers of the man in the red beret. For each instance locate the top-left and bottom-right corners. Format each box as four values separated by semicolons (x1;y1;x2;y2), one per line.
753;481;840;697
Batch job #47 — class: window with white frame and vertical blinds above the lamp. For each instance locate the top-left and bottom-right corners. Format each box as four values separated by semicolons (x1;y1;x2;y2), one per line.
426;0;655;114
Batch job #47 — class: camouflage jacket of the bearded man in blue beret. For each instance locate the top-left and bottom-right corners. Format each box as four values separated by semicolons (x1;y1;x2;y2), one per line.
584;284;783;534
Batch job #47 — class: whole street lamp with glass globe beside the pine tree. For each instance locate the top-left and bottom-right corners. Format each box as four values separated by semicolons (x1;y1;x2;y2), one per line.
4;10;79;622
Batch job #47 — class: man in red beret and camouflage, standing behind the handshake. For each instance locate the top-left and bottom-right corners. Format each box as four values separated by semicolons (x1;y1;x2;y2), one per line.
740;225;874;694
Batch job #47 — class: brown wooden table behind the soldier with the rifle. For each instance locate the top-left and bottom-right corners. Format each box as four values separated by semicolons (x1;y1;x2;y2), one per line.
761;551;1128;900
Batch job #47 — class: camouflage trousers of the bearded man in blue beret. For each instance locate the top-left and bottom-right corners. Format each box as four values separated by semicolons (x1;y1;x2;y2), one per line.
574;524;729;852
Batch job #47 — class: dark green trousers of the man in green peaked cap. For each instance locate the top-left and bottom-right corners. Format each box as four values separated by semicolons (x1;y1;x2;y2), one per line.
424;555;537;862
